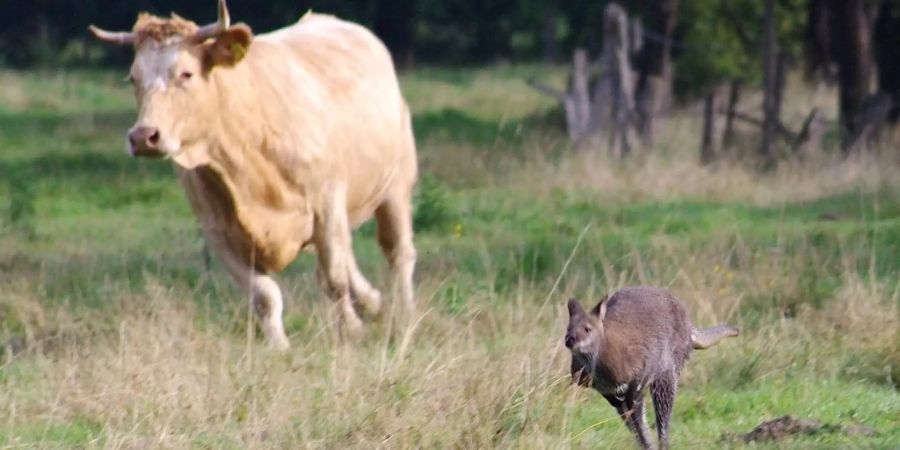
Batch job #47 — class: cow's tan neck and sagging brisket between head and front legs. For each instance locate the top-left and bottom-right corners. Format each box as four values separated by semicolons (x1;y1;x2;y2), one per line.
179;60;313;270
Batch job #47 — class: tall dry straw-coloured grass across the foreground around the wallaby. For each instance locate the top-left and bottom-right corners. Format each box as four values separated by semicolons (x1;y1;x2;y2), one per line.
0;248;900;448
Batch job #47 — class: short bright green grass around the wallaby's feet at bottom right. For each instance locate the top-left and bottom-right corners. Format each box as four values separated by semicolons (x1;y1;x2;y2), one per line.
571;381;900;448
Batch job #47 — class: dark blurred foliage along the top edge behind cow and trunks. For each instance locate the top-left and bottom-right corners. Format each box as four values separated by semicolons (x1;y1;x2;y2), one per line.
0;0;805;98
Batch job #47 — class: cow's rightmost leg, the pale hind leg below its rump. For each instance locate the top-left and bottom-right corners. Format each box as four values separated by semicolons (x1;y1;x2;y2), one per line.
375;188;416;315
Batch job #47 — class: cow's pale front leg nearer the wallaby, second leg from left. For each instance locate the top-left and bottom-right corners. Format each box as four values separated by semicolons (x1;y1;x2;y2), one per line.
315;186;362;336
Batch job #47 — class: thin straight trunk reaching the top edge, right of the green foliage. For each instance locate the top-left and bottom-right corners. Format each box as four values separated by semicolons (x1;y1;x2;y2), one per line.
759;0;778;169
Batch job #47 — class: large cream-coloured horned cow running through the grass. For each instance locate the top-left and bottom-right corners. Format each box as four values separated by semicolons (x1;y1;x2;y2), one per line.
90;0;418;350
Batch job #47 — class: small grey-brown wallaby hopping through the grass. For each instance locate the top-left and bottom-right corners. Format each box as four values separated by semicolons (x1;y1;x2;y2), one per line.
565;287;738;449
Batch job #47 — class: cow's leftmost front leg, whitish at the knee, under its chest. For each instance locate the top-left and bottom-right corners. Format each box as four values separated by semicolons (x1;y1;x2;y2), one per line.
221;252;290;350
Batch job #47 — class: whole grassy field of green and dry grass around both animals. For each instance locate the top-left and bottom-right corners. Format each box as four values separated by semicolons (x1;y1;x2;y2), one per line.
0;67;900;449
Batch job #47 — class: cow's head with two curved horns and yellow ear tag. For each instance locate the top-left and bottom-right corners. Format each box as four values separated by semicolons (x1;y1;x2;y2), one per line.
90;0;253;162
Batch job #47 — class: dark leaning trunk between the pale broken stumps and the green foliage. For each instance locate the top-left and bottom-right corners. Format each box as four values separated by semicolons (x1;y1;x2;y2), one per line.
635;0;678;145
